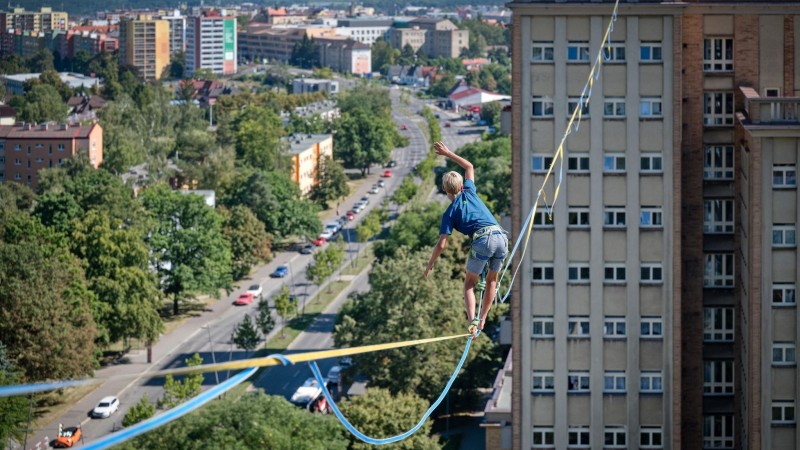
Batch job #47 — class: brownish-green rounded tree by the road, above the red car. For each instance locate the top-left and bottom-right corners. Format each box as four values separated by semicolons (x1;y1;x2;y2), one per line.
220;205;272;280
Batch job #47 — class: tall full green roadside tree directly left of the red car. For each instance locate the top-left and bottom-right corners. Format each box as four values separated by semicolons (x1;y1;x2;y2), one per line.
141;185;231;315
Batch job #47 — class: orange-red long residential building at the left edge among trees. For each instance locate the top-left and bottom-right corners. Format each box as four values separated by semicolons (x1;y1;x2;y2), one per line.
0;123;103;189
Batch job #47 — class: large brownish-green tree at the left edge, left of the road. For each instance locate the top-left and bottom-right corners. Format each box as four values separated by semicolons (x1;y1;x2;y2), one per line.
0;212;96;381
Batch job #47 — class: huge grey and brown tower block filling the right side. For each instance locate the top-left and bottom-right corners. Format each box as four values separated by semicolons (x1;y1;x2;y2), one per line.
510;1;800;450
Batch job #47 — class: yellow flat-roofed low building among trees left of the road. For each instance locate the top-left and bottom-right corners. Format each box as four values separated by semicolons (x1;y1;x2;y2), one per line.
286;134;333;195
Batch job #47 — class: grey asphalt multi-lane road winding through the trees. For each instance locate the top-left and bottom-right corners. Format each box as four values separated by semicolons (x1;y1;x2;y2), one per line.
28;86;456;448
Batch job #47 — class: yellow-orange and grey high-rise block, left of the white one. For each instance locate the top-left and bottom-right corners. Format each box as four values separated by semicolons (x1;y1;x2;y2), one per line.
119;15;170;81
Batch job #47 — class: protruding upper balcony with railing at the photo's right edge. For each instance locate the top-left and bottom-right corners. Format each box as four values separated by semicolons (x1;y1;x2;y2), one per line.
736;87;800;137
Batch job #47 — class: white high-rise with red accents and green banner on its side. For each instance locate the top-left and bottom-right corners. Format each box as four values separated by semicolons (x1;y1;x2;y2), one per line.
186;11;237;76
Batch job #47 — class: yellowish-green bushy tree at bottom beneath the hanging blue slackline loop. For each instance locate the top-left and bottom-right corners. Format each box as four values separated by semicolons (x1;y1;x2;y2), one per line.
339;388;442;450
